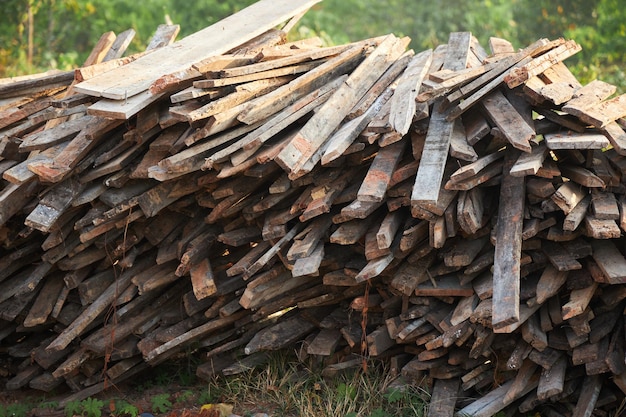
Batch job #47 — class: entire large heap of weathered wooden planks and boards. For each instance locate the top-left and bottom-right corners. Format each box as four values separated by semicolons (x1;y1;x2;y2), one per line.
0;0;626;417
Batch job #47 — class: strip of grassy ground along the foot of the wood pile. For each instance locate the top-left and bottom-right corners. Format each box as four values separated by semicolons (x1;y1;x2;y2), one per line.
0;351;428;417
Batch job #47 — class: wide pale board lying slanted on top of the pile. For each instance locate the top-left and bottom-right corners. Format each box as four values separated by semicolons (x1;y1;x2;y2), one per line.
75;0;318;100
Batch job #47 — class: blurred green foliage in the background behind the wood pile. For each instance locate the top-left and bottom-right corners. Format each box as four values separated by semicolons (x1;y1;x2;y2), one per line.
0;0;626;91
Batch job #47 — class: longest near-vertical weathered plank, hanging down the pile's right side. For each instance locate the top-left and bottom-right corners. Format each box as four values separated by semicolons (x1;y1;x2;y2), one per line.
492;151;525;332
